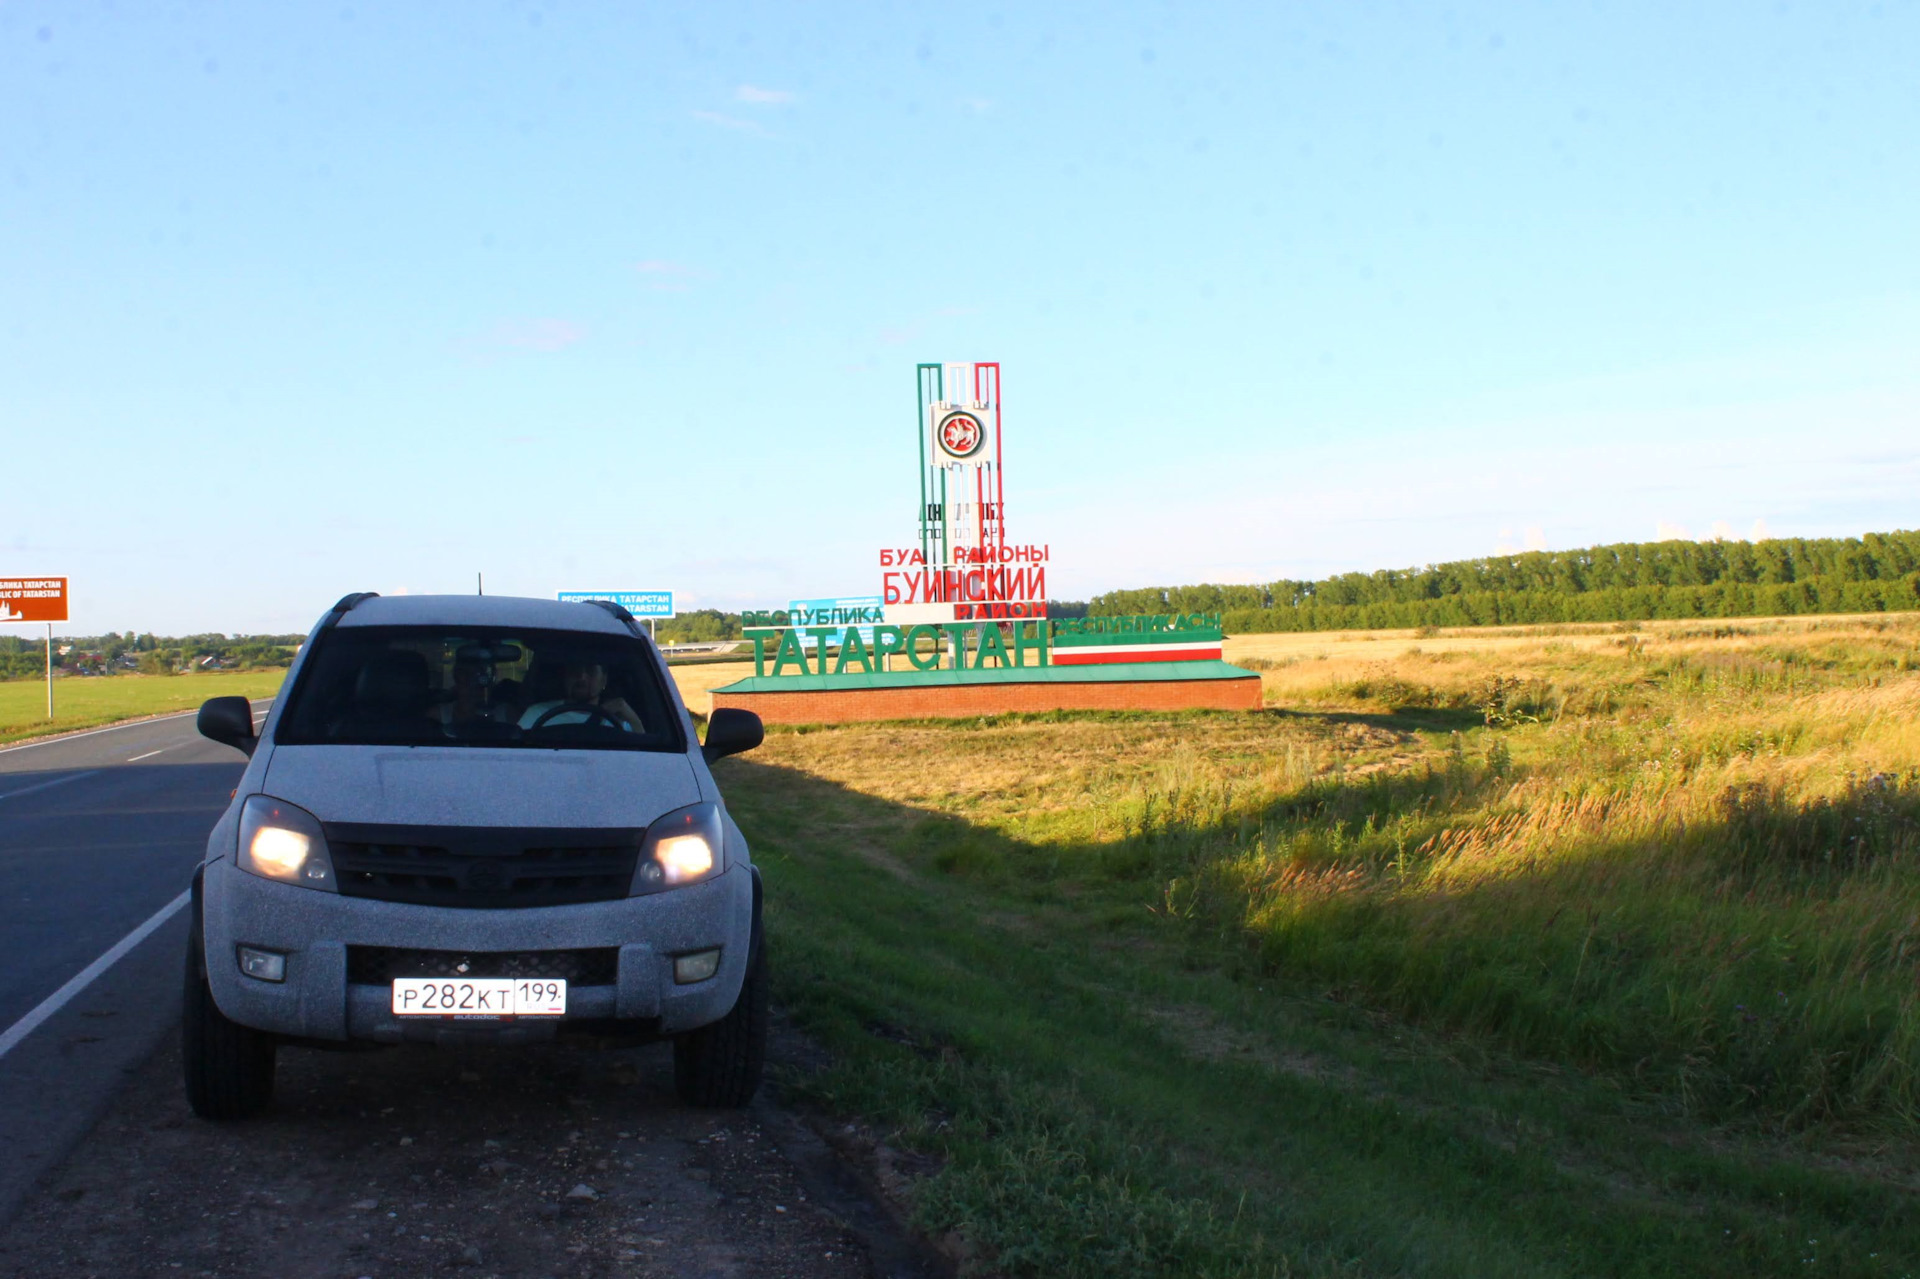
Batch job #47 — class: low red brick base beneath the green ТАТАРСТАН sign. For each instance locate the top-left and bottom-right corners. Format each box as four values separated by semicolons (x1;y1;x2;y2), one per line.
708;674;1260;724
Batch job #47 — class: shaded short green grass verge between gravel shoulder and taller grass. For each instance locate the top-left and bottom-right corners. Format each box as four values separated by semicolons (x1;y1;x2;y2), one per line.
741;762;1920;1275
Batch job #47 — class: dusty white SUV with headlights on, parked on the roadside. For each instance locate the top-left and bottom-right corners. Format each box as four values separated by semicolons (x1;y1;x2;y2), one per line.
182;595;768;1120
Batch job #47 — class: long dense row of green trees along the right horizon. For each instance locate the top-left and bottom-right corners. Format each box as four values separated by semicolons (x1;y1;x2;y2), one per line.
1092;532;1920;632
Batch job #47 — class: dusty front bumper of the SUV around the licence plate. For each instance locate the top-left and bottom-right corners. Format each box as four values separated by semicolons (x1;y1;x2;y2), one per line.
202;858;753;1043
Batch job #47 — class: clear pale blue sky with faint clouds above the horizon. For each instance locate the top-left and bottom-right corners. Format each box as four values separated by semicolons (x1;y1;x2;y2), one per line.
0;0;1920;634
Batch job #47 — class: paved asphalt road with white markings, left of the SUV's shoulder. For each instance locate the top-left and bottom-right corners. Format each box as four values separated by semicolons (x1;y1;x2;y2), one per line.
0;703;269;1221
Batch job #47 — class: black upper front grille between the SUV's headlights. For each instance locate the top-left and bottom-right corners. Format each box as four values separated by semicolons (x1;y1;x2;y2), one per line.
324;822;647;910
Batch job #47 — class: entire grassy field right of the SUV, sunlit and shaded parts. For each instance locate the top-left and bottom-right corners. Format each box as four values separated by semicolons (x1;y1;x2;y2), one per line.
721;616;1920;1275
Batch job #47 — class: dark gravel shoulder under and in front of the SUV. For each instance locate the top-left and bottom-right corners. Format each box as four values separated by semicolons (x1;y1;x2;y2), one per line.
0;1041;941;1279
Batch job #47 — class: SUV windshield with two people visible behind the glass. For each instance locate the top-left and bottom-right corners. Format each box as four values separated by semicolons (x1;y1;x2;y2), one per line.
275;626;685;751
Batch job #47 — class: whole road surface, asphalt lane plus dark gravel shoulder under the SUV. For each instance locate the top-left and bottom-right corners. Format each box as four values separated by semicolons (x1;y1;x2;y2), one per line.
0;703;936;1279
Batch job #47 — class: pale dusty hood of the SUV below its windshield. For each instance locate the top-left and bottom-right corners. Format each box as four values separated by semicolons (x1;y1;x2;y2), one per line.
261;745;701;828
